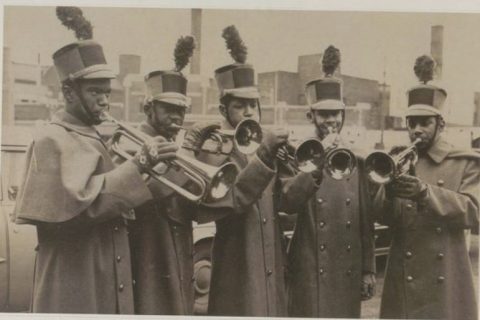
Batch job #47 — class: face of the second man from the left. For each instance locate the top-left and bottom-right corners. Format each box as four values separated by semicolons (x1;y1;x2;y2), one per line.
146;101;186;139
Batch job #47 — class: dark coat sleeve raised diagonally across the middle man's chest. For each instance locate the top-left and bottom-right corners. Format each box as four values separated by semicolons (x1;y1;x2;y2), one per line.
197;155;276;223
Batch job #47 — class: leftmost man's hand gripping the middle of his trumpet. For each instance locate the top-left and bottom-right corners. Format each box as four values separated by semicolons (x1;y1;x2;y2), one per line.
134;136;178;173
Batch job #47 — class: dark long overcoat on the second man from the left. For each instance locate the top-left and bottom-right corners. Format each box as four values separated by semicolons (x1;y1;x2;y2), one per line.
123;122;196;315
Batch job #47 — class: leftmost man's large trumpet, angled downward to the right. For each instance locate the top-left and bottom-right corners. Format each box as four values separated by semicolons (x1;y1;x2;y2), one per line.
100;111;238;202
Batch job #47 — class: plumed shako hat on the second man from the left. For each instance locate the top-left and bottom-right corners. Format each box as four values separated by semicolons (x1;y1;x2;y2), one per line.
145;36;195;108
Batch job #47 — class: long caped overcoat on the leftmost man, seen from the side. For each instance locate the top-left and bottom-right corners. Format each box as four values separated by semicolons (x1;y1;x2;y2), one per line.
14;112;152;314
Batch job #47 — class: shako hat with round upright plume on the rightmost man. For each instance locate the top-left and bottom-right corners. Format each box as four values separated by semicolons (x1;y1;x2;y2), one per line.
406;55;447;117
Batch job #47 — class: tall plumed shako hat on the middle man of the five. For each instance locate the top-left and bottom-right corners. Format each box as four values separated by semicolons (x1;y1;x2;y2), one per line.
215;25;260;99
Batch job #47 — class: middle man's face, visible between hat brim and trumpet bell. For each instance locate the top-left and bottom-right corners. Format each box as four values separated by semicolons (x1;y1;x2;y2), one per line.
220;97;260;127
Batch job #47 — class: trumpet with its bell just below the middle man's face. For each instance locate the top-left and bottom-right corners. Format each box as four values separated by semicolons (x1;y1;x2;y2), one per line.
202;119;261;155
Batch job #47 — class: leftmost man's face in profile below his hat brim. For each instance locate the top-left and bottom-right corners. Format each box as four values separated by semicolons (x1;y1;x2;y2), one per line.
64;79;111;125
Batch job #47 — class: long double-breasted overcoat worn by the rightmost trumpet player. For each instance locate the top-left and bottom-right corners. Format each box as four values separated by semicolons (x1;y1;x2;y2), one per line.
374;137;480;319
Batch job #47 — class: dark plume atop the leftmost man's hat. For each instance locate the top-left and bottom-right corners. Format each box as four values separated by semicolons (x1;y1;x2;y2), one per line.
56;7;93;40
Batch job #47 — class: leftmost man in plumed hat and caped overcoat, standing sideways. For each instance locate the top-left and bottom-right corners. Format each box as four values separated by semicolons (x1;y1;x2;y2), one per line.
14;7;178;314
